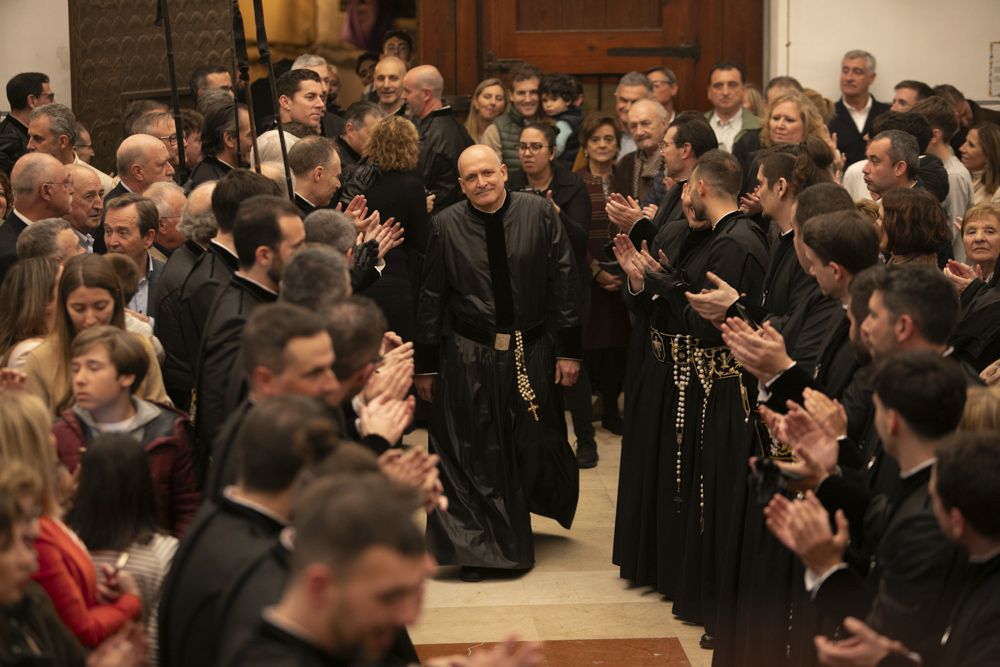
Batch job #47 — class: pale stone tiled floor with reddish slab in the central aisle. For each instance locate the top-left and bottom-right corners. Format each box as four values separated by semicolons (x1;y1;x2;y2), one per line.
408;429;712;667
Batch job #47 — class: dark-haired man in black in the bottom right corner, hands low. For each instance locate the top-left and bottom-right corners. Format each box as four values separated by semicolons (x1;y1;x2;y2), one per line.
816;433;1000;667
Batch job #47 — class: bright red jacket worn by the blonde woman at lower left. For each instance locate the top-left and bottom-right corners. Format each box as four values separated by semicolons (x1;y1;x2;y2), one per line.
33;517;142;648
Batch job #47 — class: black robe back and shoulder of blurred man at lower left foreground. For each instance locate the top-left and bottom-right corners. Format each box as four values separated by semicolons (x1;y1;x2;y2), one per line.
159;498;283;667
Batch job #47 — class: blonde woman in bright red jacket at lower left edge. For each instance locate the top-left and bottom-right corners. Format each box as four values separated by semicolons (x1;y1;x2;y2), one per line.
0;391;142;648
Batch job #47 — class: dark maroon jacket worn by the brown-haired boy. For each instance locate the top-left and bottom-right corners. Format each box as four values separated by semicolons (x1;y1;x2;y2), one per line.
52;399;201;537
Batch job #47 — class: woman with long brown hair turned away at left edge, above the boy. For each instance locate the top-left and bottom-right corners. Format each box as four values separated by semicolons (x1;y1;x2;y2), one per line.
0;257;62;370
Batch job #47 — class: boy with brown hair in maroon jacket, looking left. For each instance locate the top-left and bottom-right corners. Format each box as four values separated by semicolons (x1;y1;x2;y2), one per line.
52;325;201;536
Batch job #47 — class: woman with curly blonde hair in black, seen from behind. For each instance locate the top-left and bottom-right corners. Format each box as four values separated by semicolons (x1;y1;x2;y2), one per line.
355;116;430;341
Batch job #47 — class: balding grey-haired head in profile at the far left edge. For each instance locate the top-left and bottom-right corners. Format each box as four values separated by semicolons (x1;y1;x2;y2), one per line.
10;152;73;221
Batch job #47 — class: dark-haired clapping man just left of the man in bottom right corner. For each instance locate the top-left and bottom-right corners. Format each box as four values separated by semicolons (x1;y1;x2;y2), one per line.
769;351;966;648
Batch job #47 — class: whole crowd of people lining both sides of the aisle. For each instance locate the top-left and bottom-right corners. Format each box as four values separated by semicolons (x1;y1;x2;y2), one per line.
0;24;1000;667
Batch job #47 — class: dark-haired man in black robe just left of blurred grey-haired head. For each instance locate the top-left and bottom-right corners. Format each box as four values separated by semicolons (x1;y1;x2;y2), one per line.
195;194;305;461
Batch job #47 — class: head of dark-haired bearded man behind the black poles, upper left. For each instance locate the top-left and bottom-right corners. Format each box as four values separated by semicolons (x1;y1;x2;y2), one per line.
186;102;253;189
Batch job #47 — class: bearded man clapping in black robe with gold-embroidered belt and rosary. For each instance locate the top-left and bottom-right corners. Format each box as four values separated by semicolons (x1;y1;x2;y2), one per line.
615;150;767;629
